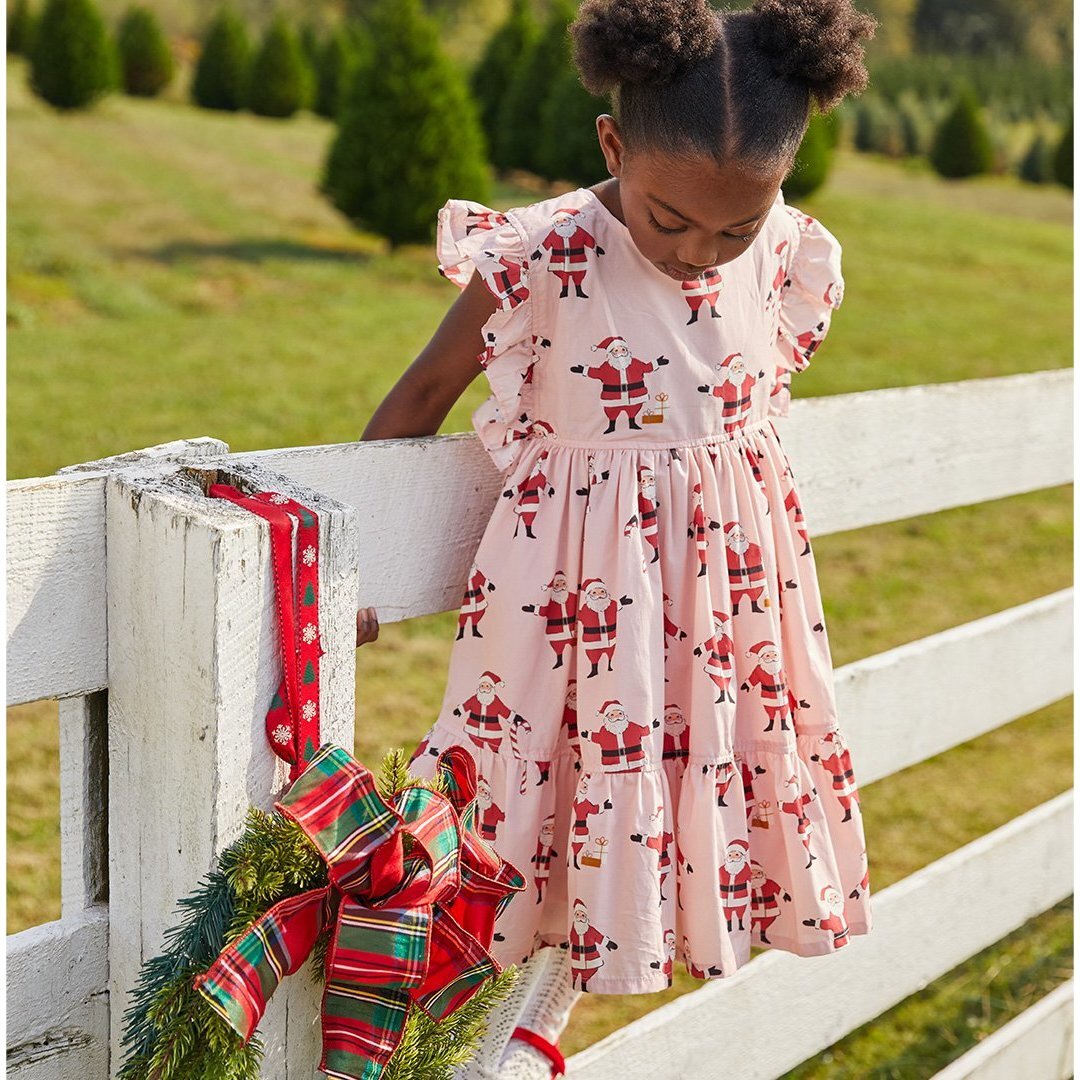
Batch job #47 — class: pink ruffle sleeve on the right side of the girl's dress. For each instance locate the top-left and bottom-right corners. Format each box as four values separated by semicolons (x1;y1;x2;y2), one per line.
769;194;843;416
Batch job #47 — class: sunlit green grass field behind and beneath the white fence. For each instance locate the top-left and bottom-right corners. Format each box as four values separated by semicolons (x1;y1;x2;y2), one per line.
8;60;1072;1080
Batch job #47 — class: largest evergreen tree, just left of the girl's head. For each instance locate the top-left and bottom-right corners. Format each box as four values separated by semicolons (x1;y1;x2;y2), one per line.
320;0;489;246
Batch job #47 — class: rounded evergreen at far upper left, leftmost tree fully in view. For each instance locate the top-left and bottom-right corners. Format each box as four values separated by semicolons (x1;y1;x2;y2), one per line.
29;0;116;110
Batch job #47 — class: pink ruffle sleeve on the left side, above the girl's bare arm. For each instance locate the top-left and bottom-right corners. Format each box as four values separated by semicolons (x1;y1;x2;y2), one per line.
435;199;539;472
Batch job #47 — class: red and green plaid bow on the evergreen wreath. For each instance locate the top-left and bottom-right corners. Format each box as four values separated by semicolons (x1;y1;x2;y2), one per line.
194;743;525;1080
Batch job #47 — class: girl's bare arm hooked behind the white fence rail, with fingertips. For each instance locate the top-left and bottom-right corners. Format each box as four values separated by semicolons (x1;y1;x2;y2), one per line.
356;272;498;648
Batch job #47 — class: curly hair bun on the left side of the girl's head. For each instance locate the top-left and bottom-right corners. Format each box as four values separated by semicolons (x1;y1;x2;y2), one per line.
569;0;720;96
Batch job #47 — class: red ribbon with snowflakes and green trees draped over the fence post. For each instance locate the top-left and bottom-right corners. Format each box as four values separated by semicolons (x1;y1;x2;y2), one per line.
207;484;317;782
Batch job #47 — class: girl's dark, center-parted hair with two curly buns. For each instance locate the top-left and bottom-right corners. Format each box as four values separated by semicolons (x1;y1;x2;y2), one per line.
569;0;878;173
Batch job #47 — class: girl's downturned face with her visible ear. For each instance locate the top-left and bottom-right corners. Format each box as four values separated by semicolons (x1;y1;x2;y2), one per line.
596;113;786;280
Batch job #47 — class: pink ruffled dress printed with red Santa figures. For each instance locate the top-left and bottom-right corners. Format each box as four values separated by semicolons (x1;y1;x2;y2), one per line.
411;188;872;994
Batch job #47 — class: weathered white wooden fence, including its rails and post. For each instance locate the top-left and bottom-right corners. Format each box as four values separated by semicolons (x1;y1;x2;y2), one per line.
8;372;1072;1080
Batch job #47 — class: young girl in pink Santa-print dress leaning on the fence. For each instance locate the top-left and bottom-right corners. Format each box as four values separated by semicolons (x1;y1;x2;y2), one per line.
359;0;876;1075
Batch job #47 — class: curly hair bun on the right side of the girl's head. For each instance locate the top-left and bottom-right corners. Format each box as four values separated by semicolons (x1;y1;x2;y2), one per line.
751;0;878;112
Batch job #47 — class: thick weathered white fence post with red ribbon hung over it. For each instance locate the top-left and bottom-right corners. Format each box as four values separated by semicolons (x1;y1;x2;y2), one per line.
106;458;359;1080
